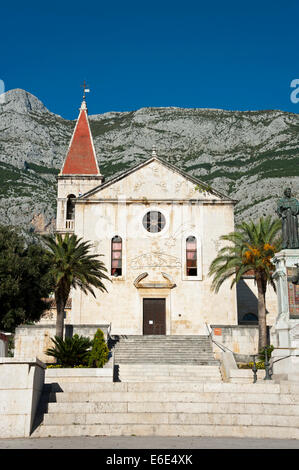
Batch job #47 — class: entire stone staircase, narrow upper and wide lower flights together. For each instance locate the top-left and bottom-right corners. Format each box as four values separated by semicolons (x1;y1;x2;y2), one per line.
31;336;299;439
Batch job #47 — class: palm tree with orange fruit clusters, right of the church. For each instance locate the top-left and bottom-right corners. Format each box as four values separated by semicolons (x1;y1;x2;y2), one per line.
209;216;281;350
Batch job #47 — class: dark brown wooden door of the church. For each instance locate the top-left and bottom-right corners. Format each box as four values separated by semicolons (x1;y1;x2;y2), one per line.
143;299;166;335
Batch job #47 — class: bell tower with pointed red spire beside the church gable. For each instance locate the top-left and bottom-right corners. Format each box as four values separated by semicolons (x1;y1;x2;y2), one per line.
56;90;104;233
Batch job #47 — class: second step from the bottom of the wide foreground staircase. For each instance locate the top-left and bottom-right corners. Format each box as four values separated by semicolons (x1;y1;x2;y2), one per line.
44;412;299;427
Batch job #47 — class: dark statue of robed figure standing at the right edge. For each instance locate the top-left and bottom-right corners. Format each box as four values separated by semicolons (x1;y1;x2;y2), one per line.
276;188;299;249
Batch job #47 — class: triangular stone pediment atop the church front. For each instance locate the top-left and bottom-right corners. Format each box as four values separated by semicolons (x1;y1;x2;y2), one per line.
80;157;232;202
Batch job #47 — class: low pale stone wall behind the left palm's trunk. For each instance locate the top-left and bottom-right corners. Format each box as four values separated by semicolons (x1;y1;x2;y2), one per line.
14;325;110;363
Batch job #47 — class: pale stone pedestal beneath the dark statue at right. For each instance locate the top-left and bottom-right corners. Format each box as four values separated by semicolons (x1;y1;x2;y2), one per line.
271;249;299;380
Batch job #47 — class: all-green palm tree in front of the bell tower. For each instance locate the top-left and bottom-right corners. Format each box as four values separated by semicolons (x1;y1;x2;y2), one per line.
43;233;109;338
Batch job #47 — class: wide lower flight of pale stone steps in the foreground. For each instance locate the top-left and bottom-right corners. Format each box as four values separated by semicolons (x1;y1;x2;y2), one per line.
31;380;299;439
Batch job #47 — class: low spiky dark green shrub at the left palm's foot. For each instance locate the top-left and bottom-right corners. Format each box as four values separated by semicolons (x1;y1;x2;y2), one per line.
46;335;92;367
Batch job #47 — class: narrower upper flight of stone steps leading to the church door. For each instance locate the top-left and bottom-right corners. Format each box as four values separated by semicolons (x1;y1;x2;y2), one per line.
112;335;221;382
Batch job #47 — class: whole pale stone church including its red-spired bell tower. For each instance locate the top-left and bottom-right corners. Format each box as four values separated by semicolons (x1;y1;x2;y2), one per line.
56;100;238;335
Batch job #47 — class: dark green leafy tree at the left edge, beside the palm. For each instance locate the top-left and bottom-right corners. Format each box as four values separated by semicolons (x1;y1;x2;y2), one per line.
0;226;52;332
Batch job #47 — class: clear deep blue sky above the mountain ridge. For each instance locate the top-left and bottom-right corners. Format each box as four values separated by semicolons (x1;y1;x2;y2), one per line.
0;0;299;119
